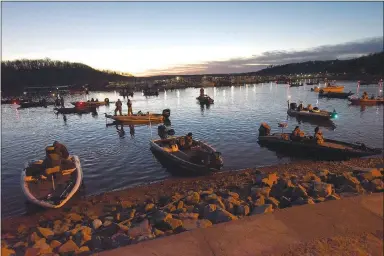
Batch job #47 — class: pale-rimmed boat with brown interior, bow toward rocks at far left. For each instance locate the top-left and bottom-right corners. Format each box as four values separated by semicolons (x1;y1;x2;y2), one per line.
20;155;83;208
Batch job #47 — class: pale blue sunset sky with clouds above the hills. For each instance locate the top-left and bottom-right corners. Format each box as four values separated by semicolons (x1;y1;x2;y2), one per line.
2;2;383;76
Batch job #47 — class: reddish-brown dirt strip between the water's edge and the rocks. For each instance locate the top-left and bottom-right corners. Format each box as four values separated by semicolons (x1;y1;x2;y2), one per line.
1;157;384;226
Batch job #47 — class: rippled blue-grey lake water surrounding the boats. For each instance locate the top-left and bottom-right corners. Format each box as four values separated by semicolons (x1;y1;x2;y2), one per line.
1;82;383;217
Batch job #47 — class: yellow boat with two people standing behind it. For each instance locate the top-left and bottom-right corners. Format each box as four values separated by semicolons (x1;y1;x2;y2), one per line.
105;109;171;124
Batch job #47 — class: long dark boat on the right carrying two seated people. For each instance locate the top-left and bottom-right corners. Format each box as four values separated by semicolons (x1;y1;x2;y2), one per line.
258;124;382;160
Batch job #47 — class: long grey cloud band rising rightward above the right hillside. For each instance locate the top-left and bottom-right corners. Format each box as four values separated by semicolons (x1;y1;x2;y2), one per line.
139;37;383;76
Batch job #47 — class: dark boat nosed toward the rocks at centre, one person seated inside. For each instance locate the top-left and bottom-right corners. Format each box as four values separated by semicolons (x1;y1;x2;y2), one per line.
150;136;223;176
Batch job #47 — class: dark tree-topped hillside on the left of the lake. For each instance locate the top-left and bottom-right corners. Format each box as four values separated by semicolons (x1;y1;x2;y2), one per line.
1;59;132;95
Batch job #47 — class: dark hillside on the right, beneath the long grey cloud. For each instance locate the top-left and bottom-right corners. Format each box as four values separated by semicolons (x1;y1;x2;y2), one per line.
247;52;384;76
